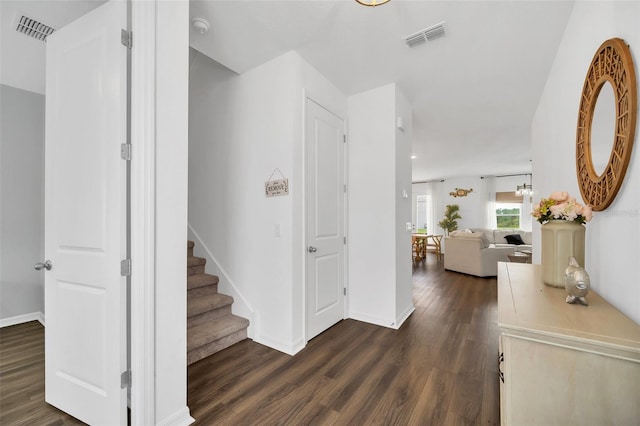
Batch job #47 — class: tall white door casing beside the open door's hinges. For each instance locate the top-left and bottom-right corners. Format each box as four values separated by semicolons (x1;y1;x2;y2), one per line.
131;0;155;425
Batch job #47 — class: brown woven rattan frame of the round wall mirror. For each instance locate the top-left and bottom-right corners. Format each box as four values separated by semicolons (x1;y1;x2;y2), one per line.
576;38;638;211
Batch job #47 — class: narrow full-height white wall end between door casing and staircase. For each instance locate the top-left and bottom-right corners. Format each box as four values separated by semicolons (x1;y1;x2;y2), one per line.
154;0;190;425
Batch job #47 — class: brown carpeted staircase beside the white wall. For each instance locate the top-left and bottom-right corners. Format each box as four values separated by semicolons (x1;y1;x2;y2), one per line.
187;241;249;364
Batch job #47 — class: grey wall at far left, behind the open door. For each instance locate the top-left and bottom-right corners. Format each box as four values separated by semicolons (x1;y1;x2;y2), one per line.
0;85;44;326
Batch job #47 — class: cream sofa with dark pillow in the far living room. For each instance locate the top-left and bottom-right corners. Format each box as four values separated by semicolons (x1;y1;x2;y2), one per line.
444;229;531;277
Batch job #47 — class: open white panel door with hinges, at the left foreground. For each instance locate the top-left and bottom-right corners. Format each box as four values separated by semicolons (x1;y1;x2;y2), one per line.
45;0;127;425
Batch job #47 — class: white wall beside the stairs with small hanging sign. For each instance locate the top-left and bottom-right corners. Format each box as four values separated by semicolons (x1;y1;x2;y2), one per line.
189;52;346;354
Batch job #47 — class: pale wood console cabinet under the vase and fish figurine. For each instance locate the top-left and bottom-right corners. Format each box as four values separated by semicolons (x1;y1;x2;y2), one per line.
498;262;640;426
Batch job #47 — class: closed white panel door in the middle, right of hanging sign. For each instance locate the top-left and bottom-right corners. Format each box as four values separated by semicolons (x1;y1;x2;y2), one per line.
305;98;345;340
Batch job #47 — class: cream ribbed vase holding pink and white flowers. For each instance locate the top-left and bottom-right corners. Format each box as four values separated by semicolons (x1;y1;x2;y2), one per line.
542;220;586;288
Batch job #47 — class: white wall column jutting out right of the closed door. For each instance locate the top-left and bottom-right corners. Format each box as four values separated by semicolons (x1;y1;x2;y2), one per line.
348;84;412;328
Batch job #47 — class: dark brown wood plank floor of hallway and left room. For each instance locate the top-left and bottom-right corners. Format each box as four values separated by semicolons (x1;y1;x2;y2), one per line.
0;254;499;426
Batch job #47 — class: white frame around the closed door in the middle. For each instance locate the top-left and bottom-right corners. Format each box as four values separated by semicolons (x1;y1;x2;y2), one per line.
300;89;349;346
